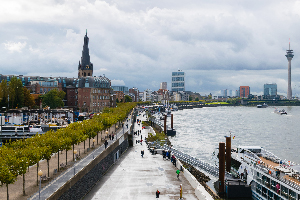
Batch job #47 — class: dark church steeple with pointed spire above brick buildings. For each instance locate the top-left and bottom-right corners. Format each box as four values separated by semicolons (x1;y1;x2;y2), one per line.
78;31;93;78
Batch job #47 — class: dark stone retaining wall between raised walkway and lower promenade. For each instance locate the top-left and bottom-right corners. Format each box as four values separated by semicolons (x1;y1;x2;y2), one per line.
48;133;129;200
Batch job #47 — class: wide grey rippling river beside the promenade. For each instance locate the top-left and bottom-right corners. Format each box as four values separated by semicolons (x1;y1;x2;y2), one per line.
168;106;300;164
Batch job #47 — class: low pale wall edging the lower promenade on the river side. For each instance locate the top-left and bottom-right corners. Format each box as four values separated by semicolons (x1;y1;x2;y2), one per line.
176;159;213;200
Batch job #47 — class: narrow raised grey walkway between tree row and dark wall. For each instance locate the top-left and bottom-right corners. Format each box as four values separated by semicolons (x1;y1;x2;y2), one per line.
29;115;131;200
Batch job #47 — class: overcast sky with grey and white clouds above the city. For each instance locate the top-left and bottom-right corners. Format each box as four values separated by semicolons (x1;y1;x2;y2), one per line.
0;0;300;96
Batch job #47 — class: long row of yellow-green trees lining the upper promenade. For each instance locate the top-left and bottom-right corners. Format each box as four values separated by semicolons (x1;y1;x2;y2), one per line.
0;103;136;198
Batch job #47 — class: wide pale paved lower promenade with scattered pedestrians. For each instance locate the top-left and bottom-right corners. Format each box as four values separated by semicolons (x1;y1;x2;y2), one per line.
84;111;197;200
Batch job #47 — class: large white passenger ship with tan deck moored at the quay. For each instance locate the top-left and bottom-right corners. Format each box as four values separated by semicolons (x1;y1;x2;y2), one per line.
232;146;300;200
